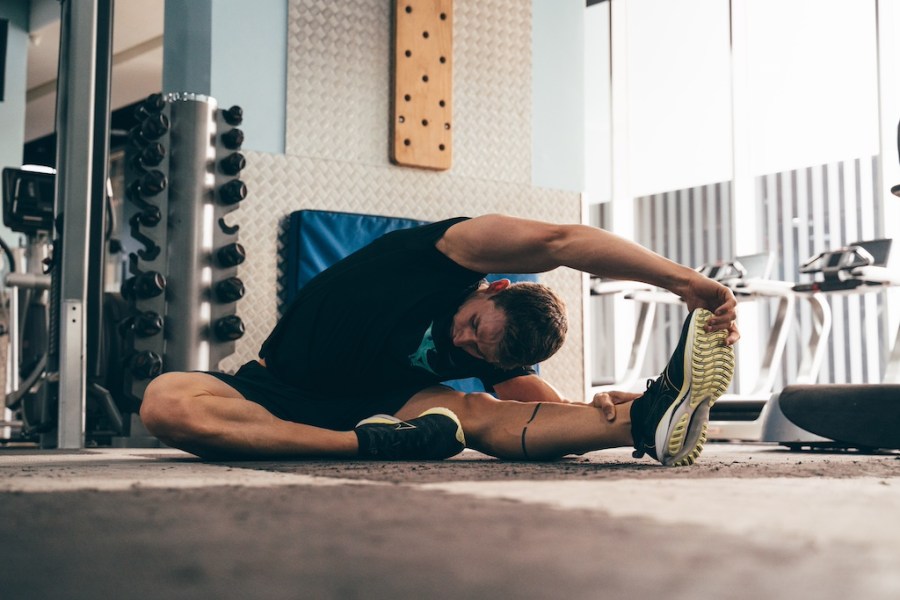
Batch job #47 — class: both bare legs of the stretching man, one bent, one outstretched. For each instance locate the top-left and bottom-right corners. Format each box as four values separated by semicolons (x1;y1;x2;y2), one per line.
141;373;632;459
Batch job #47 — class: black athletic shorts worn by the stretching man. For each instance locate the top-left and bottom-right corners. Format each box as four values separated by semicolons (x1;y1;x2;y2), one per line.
208;360;430;431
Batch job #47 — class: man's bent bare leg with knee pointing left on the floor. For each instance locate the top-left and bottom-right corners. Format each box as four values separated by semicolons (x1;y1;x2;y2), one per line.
141;373;359;458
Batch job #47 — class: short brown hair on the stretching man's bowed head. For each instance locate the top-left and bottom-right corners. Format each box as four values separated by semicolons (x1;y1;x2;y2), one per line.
491;282;569;369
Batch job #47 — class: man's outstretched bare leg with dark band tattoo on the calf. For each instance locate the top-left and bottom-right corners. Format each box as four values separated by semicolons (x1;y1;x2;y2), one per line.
395;387;633;459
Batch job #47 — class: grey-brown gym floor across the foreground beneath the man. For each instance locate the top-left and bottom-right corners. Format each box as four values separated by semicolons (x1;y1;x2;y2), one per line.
0;444;900;600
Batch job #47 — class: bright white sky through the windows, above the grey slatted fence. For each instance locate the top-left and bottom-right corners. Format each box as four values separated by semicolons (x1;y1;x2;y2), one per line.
585;0;888;201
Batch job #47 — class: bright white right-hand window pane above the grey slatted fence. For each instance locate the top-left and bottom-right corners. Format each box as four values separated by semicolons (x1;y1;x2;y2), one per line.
738;0;878;175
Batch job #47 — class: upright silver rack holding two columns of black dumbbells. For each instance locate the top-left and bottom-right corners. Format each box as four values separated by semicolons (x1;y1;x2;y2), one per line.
122;94;247;420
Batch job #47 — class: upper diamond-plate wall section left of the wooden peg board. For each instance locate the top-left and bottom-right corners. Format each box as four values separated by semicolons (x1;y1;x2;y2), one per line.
285;0;391;164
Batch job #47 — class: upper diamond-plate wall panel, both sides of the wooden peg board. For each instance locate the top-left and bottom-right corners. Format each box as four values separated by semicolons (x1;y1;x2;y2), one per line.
285;0;531;184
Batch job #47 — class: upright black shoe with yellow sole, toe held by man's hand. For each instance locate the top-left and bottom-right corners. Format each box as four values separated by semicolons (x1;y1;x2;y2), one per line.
631;309;734;466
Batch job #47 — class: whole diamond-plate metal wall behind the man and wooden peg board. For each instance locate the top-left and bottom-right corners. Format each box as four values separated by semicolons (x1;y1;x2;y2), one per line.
220;0;585;400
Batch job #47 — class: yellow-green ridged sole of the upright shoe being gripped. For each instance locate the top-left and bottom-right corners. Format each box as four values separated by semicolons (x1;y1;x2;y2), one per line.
656;309;734;467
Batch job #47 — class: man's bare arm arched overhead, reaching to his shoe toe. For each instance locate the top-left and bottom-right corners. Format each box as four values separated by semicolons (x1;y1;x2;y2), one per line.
437;215;740;344
